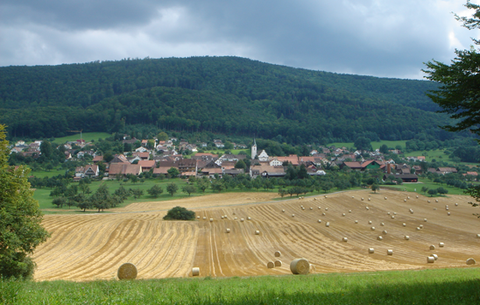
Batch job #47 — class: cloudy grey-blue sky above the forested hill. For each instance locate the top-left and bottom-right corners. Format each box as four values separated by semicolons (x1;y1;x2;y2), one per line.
0;0;478;79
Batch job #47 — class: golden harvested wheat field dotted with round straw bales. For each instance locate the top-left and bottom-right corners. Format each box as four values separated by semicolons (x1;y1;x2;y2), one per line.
33;190;480;281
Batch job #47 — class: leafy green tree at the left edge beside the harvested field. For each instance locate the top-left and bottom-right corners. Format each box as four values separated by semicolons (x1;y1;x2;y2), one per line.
0;125;49;278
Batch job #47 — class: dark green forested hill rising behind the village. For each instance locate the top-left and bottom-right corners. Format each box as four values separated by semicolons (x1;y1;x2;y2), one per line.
0;57;451;143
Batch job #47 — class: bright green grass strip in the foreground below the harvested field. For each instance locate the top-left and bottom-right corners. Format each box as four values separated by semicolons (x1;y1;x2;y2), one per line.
0;268;480;305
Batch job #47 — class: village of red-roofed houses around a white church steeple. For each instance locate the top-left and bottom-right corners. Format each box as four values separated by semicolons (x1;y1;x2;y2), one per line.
10;135;472;183
